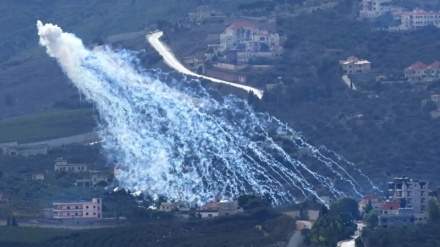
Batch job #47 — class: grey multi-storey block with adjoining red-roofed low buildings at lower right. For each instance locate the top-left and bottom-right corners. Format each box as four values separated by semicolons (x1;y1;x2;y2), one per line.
359;176;430;227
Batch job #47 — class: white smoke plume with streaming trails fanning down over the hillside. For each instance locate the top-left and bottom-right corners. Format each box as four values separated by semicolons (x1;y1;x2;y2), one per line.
37;21;377;204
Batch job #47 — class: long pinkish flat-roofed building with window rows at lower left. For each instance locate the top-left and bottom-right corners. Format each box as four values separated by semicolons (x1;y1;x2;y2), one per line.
52;198;102;219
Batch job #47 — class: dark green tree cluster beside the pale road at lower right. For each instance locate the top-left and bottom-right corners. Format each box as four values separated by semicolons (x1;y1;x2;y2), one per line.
304;198;360;246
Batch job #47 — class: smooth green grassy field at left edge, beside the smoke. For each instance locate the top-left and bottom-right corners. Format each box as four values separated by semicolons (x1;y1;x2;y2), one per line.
0;108;95;143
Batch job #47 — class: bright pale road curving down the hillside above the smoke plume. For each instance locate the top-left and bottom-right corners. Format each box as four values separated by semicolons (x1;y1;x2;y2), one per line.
147;31;263;99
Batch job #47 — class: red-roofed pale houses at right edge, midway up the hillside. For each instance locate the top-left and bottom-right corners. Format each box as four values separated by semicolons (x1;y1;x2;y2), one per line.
404;61;440;82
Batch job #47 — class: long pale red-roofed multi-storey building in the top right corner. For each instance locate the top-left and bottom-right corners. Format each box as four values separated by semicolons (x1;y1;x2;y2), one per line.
396;9;440;30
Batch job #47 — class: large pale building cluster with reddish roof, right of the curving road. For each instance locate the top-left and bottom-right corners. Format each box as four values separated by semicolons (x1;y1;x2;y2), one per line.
219;21;283;63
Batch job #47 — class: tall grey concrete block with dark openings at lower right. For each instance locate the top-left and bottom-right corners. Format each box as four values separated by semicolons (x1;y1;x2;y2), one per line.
388;176;429;214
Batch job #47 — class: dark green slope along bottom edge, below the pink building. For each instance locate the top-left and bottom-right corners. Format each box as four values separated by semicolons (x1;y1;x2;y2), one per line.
0;210;295;247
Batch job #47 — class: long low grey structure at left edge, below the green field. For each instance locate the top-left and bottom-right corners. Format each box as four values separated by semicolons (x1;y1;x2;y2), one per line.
1;142;49;157
